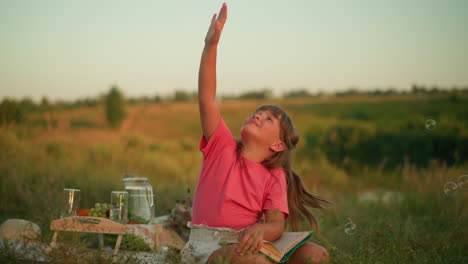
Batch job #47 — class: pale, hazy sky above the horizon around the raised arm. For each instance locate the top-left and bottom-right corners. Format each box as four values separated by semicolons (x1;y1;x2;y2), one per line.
0;0;468;100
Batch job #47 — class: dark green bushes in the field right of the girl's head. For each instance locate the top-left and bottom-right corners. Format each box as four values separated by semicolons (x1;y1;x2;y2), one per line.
316;124;468;171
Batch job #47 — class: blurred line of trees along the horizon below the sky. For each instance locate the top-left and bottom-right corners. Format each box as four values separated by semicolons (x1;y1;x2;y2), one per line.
0;84;468;127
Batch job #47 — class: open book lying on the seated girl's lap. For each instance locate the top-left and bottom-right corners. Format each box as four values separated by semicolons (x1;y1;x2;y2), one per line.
260;231;313;263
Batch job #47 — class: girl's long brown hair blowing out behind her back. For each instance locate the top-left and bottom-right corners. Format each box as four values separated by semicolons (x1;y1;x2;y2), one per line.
238;105;329;231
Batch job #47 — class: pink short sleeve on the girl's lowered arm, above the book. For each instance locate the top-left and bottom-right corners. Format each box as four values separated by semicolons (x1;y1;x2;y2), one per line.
262;168;289;217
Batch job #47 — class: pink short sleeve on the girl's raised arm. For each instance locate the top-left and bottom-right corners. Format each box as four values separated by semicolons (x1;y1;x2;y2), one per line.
198;119;236;159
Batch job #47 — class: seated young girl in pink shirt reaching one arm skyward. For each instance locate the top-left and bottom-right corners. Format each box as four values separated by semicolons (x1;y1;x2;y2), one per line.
182;3;328;263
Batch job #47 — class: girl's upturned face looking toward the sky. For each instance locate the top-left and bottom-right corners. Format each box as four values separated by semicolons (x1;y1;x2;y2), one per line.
241;110;281;151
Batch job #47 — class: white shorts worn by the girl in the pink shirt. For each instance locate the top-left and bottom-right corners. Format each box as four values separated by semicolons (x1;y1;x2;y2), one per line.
181;222;242;264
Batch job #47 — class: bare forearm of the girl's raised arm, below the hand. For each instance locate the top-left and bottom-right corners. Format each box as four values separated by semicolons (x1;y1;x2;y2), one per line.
198;45;218;104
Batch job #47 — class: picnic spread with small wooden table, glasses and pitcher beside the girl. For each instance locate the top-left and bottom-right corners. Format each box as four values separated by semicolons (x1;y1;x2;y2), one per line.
1;174;185;263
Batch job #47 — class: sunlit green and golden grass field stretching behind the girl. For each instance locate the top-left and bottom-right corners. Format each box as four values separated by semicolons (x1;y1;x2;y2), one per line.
0;96;468;264
